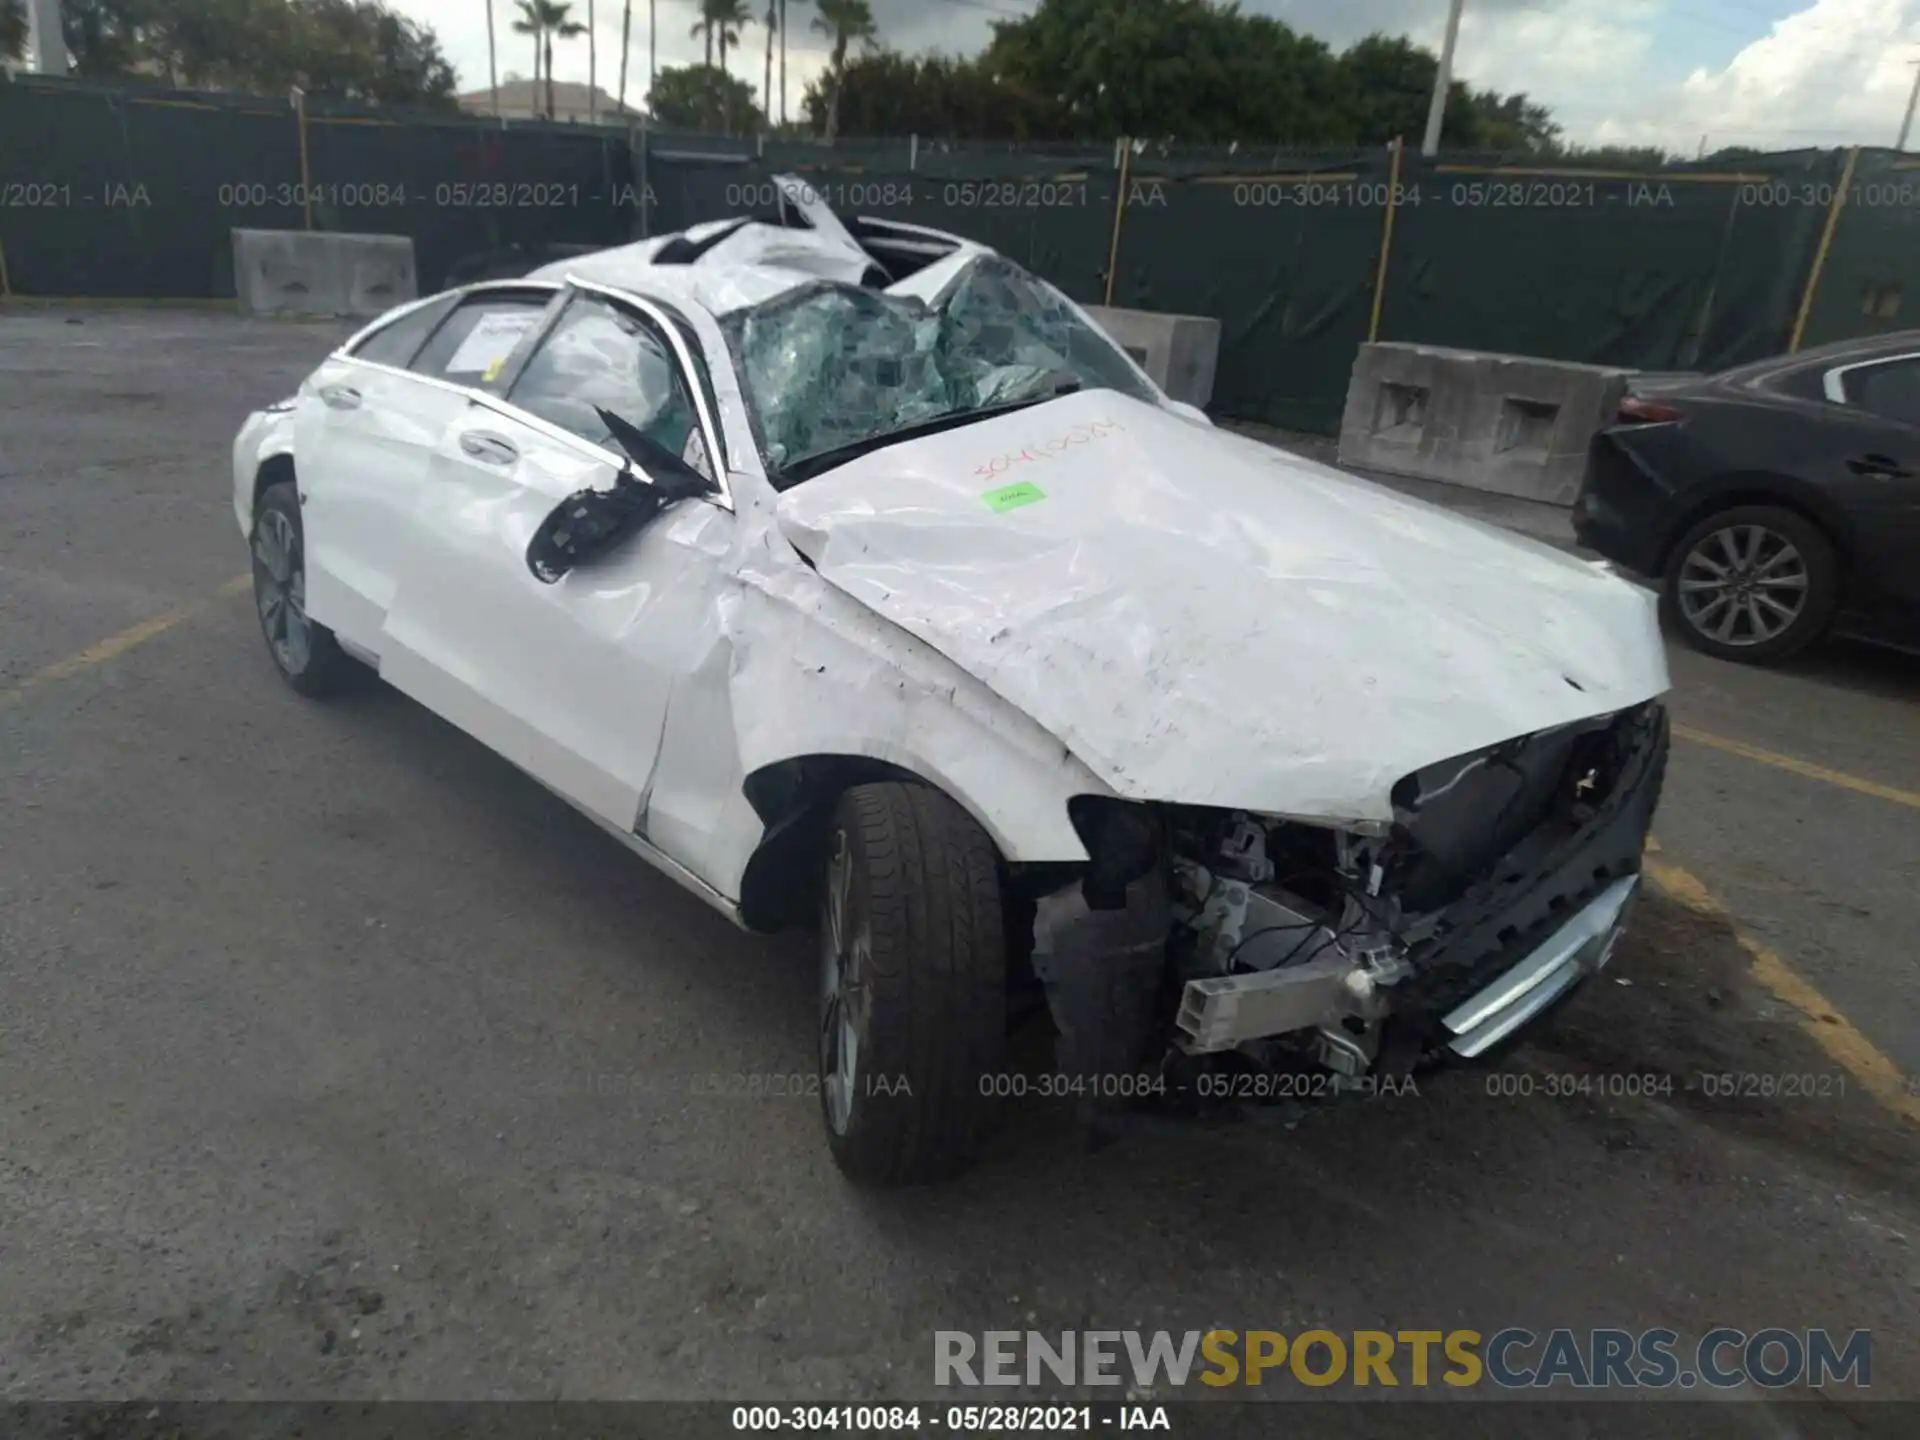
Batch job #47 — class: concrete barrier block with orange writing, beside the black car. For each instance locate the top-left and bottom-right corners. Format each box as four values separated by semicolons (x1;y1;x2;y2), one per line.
1340;344;1636;505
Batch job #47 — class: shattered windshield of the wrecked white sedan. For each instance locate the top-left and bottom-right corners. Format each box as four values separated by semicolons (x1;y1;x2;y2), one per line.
722;255;1156;488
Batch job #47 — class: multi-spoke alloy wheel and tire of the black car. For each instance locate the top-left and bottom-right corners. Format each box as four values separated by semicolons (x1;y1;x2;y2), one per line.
1663;505;1839;664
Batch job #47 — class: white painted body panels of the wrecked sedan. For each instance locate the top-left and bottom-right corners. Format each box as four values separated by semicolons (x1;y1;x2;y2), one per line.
234;192;1667;917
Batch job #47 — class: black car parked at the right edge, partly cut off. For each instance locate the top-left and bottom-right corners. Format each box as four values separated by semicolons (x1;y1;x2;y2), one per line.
1572;330;1920;664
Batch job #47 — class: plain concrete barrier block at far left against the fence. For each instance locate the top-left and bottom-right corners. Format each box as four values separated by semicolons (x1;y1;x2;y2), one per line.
234;230;419;315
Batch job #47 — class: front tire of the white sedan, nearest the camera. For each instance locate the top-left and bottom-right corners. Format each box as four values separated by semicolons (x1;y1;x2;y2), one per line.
820;783;1006;1187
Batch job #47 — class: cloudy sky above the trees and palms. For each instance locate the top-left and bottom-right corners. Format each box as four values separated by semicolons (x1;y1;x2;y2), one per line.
405;0;1920;152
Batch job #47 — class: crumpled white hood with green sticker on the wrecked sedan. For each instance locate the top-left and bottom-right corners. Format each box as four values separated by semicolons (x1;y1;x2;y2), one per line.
780;390;1668;820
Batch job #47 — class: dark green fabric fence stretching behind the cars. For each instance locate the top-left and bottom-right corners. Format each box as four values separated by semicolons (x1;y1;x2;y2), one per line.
0;81;1920;432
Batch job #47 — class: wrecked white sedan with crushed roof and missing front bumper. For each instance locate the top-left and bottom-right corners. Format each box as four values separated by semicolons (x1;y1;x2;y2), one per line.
234;182;1667;1185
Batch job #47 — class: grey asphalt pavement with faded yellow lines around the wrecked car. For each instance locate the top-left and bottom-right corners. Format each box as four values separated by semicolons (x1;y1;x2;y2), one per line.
0;311;1920;1436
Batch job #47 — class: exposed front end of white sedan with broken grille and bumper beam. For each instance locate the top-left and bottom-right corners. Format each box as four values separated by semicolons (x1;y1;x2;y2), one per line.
1033;703;1668;1091
